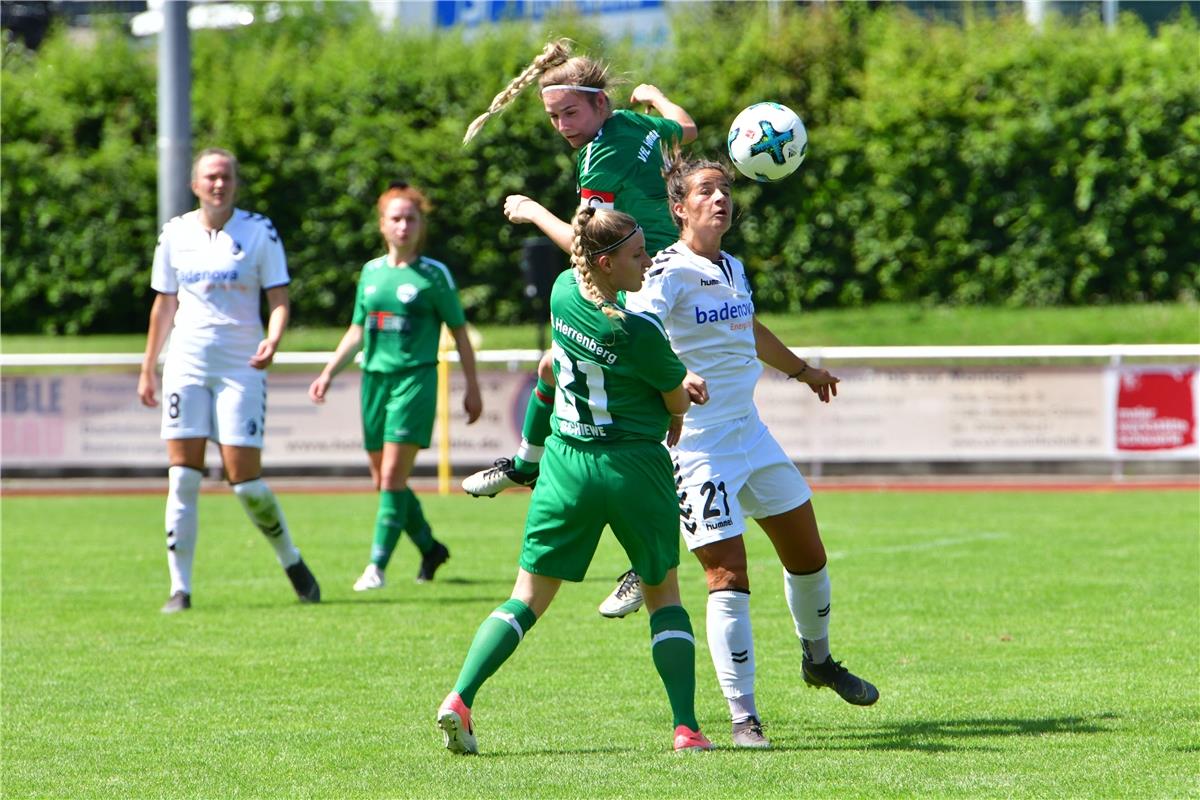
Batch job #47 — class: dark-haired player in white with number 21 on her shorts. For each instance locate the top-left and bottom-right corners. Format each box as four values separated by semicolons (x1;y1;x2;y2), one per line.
628;158;878;747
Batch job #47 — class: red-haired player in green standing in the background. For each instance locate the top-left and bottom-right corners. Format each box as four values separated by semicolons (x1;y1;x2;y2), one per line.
308;184;484;591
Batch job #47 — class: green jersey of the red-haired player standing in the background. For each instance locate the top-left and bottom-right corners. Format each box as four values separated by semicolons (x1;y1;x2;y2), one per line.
353;255;466;372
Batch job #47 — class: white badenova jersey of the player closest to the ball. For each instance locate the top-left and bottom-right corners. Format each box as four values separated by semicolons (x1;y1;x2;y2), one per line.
625;242;762;428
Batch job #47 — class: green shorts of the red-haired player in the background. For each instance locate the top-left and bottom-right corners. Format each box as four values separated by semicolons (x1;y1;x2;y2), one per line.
362;365;438;452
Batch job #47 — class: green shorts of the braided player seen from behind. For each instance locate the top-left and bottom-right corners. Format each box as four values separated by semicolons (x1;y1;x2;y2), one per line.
521;435;679;587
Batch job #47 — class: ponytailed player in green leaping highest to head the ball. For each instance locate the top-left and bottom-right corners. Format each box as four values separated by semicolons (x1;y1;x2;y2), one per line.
463;40;696;513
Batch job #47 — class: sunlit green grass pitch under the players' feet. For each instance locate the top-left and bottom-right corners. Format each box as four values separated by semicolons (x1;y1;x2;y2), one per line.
0;488;1200;798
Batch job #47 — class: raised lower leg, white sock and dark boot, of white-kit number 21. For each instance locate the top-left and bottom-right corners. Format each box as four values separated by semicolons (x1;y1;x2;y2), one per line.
784;566;880;705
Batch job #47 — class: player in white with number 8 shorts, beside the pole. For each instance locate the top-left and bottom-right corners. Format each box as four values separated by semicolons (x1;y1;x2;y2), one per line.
138;148;320;614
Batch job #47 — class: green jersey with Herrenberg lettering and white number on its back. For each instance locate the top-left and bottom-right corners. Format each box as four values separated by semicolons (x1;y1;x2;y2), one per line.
550;270;688;444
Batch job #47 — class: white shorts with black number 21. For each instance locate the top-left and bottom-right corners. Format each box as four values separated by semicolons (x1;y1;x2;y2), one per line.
671;414;812;551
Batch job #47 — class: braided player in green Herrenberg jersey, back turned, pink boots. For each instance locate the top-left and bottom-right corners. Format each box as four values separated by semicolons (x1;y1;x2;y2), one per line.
437;207;712;753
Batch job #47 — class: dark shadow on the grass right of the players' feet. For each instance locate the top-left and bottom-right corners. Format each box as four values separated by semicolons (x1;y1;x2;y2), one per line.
774;714;1117;753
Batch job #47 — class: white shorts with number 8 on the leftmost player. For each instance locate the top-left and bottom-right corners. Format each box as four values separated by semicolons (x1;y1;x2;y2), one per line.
162;361;266;450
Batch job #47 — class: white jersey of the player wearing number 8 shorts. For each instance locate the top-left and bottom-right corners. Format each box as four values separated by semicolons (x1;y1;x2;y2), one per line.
150;209;290;374
